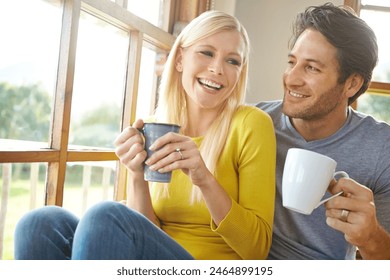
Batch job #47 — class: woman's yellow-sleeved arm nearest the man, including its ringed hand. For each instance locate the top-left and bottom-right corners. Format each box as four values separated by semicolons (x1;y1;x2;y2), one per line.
146;108;276;259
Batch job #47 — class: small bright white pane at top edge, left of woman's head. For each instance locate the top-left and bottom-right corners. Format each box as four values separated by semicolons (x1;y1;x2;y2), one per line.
127;0;162;27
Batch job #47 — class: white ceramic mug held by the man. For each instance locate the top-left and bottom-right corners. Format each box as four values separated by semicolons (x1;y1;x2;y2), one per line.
282;148;349;215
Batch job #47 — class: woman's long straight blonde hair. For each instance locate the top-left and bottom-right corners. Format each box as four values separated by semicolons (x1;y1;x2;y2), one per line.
156;11;250;200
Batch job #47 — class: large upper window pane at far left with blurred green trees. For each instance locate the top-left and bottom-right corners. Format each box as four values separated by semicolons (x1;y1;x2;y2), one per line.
0;0;62;144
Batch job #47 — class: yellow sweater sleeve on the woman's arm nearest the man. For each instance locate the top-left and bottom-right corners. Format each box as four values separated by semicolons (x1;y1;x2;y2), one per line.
211;106;276;259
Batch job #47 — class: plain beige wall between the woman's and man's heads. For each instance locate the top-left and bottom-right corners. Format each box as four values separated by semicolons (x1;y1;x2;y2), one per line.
214;0;344;103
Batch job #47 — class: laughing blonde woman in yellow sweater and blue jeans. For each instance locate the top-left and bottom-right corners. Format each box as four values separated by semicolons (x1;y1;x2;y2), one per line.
16;11;276;259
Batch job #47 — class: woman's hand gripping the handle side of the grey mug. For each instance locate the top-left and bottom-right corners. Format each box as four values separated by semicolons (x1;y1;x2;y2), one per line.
114;120;146;176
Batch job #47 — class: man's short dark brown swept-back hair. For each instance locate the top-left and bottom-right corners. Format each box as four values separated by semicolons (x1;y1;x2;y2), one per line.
290;3;378;104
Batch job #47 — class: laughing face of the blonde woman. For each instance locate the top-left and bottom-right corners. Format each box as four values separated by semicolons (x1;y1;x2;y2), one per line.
176;31;244;110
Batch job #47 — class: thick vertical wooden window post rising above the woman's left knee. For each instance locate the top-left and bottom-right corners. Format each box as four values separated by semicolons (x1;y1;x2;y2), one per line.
45;0;80;206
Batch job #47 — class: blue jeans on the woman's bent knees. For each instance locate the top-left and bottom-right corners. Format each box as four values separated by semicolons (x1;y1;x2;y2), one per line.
15;202;193;260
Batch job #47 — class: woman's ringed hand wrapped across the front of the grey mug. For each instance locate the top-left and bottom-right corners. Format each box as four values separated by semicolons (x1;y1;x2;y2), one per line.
145;132;213;187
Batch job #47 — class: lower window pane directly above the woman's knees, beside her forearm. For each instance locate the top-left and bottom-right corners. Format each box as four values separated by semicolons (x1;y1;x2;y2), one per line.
63;161;116;217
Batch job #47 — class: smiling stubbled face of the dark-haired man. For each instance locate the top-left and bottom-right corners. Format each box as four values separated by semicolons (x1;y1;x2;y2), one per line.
283;29;347;120
